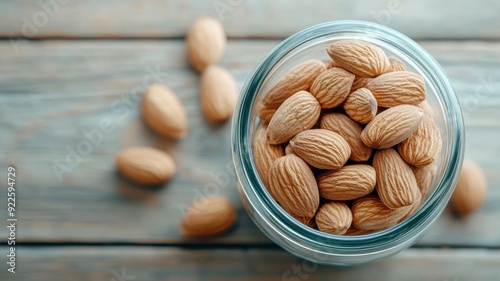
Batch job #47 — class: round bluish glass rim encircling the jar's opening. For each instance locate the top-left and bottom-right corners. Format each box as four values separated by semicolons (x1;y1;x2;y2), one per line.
231;21;464;263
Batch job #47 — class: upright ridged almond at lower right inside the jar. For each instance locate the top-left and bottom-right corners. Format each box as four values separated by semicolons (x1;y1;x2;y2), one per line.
372;148;418;209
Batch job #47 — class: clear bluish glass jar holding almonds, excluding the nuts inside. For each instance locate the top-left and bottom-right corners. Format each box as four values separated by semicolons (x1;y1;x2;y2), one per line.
232;21;464;265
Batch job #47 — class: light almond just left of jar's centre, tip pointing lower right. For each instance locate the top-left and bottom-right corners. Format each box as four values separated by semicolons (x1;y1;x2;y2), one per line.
290;129;351;170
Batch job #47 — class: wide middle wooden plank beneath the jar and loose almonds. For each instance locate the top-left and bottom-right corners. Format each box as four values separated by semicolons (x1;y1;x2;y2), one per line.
0;40;500;247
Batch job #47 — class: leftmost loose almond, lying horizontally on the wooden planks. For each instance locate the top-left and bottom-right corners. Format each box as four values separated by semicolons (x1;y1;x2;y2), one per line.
115;147;176;185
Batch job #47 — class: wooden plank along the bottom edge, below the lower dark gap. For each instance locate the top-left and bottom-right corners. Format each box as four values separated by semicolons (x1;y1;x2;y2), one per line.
0;247;500;281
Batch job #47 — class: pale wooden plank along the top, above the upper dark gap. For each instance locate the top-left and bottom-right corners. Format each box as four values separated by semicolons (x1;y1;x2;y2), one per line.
0;0;500;39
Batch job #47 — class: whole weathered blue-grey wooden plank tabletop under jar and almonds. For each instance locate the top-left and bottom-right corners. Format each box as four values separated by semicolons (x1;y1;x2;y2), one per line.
0;0;500;281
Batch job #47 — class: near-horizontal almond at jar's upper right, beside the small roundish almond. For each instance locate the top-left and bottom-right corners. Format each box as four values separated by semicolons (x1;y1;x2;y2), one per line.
366;71;425;107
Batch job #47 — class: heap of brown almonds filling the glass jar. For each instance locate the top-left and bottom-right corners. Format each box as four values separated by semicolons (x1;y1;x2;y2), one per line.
253;40;442;232
